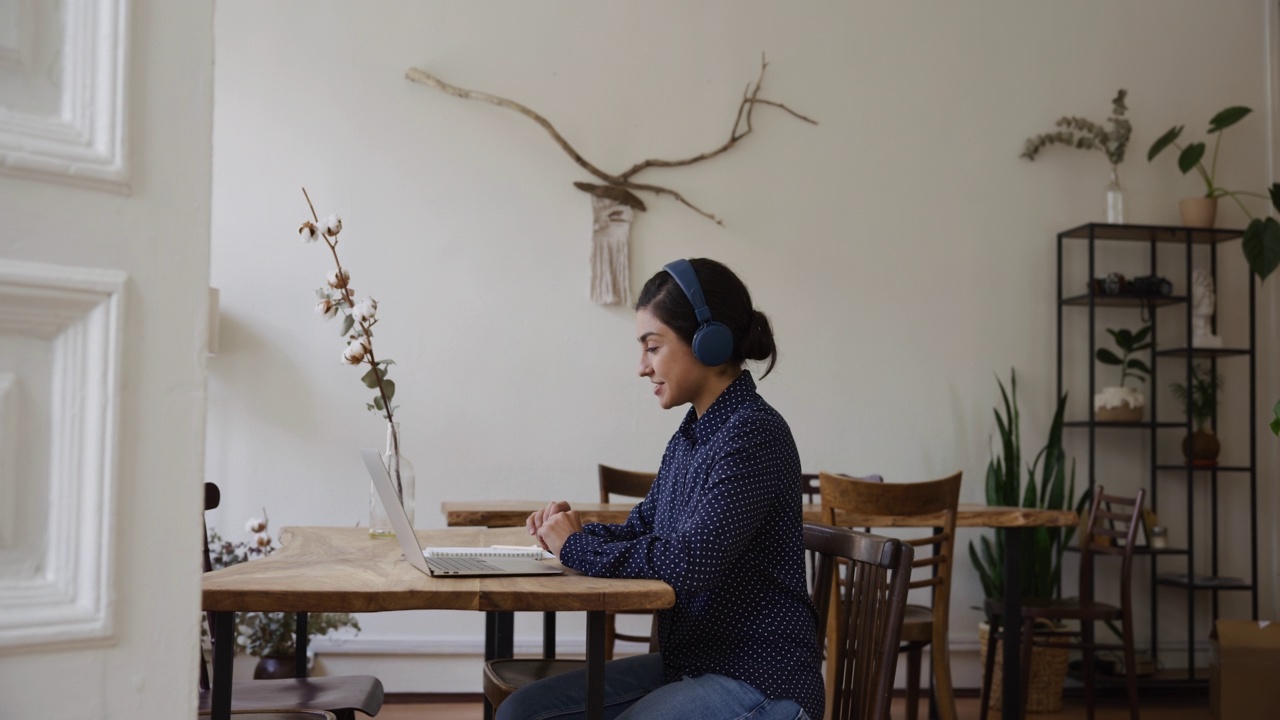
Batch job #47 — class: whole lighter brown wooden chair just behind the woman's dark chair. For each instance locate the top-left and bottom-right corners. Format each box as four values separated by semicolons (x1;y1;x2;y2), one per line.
819;473;961;720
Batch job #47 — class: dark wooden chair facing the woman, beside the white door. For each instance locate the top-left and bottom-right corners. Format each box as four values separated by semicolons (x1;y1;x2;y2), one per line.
198;483;383;720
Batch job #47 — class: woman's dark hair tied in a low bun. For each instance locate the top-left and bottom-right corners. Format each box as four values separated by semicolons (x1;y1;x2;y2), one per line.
636;258;778;378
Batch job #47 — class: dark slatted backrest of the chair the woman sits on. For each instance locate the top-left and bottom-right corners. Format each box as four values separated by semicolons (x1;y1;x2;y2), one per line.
804;523;915;720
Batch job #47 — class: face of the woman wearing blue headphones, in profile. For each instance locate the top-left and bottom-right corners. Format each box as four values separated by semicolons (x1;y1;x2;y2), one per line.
636;307;722;415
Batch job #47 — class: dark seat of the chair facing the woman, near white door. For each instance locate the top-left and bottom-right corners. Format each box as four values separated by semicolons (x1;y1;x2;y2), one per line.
200;675;383;716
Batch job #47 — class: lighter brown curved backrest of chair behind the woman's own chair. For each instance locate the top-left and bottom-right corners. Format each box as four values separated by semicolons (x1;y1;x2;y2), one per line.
819;473;961;647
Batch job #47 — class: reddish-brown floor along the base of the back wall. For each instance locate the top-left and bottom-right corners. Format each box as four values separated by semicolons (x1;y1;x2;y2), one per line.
378;696;1211;720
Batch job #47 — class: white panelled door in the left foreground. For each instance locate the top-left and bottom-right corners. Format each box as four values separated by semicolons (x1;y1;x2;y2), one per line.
0;0;212;720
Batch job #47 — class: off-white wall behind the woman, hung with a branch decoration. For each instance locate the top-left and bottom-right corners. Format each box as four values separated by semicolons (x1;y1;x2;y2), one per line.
206;0;1280;692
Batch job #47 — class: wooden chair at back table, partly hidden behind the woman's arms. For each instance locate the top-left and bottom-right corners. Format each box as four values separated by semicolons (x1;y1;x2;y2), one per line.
484;465;658;710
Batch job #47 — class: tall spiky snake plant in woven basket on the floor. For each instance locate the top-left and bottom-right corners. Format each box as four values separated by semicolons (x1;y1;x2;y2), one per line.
969;370;1089;712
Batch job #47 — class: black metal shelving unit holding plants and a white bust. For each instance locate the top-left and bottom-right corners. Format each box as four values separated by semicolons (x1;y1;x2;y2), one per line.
1057;223;1258;685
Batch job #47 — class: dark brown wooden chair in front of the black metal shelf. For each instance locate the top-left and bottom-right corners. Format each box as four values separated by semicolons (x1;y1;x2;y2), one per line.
980;486;1147;720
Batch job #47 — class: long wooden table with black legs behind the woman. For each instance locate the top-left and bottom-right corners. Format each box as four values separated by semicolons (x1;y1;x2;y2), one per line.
440;500;1080;707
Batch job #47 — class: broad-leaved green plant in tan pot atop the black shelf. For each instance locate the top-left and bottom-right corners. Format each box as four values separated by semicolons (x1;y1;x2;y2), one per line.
1147;105;1280;279
